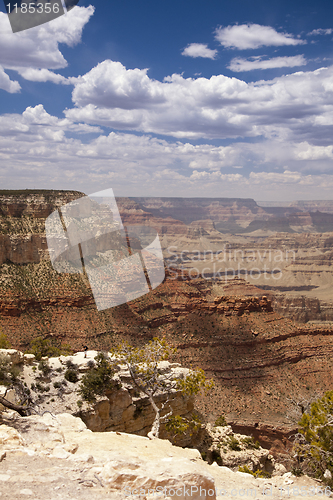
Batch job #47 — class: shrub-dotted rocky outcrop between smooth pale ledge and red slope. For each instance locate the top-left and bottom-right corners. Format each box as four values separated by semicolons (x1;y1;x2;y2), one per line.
0;349;295;468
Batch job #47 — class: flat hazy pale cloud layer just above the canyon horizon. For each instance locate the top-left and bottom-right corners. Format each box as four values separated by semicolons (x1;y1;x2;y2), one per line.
0;105;333;199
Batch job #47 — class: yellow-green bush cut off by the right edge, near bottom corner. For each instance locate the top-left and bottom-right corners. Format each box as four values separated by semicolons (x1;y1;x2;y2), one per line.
294;391;333;482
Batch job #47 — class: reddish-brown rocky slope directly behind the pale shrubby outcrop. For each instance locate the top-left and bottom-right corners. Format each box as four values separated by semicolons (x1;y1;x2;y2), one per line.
1;270;333;446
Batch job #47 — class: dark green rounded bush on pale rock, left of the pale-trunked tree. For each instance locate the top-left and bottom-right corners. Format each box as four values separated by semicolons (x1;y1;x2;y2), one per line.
79;352;115;403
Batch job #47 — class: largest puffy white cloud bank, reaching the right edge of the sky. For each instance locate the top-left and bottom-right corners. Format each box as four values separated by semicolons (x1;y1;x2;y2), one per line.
65;60;333;145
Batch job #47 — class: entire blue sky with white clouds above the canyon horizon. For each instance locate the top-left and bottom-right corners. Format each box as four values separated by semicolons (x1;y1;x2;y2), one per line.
0;0;333;201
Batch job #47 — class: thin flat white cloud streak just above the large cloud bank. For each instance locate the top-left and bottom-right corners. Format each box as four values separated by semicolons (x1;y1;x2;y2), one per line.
228;55;307;73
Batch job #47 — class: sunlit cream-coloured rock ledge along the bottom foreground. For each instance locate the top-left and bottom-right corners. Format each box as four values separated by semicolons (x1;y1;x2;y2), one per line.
0;412;324;500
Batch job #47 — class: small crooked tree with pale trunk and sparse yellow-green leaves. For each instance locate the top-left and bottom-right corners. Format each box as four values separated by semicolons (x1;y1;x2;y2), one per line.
111;338;213;439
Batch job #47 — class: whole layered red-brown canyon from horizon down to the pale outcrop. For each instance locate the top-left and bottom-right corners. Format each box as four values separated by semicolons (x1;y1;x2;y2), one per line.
0;191;333;442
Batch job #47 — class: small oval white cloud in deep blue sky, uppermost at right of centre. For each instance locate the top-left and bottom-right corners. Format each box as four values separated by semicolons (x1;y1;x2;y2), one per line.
215;24;306;50
